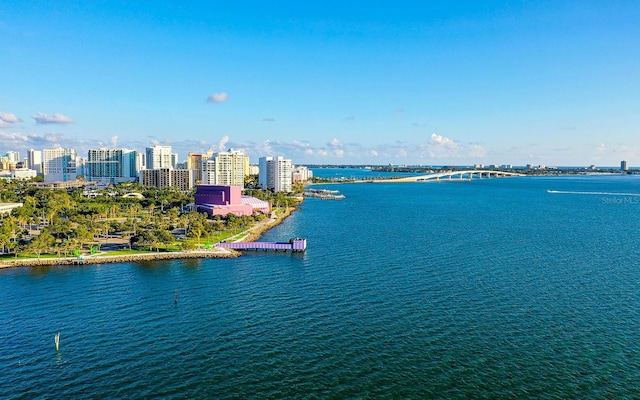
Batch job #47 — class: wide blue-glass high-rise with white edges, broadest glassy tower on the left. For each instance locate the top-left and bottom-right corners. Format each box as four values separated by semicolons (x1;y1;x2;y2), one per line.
86;149;138;183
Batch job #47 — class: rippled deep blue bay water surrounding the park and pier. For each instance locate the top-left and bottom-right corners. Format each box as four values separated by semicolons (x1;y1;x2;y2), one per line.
0;171;640;399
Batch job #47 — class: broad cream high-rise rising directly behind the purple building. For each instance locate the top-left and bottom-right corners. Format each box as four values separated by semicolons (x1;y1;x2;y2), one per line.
202;150;249;187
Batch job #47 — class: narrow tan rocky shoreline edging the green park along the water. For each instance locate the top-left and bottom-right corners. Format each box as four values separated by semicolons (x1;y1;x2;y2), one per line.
0;207;297;269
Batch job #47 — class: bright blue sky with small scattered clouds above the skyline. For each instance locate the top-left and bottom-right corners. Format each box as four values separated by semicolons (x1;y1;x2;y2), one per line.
0;0;640;165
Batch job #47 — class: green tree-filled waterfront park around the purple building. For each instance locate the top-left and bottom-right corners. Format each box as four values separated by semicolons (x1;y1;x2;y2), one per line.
0;175;303;266
